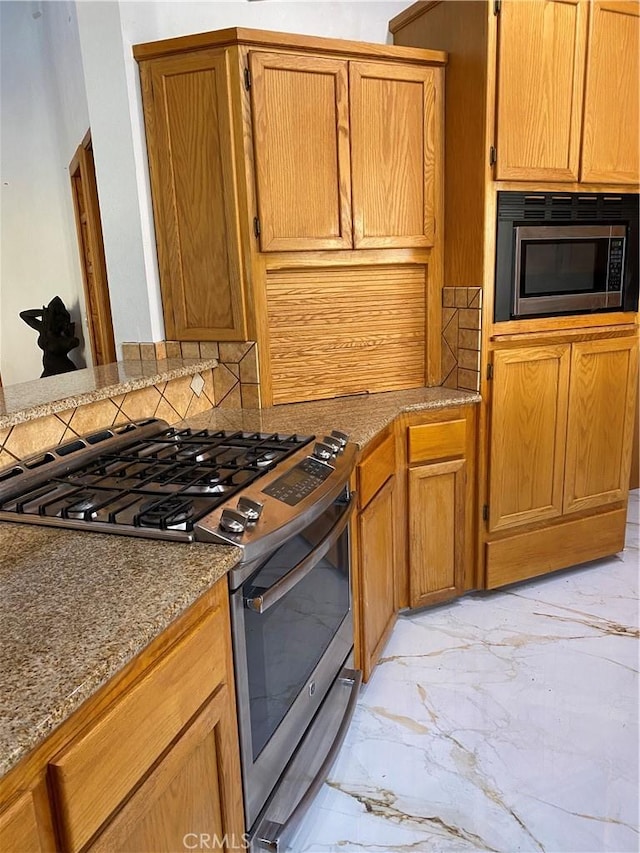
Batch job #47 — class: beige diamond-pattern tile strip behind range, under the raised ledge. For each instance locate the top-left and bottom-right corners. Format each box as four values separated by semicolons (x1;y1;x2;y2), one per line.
0;368;218;467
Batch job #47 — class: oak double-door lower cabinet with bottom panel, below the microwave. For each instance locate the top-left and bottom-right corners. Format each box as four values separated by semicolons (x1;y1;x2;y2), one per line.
478;329;638;588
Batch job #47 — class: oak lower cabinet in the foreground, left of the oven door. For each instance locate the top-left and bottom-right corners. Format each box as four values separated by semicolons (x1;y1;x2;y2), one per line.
0;578;246;853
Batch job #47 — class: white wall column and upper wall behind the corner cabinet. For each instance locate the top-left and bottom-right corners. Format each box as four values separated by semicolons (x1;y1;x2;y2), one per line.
78;0;409;352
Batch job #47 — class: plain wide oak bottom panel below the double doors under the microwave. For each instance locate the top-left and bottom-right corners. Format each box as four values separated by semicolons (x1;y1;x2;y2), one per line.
486;509;627;589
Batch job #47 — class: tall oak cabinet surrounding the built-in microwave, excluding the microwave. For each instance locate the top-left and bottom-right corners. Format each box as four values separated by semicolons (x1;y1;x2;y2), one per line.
390;0;640;587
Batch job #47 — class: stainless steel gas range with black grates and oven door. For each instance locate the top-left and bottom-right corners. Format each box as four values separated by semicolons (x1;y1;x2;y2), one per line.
0;418;360;850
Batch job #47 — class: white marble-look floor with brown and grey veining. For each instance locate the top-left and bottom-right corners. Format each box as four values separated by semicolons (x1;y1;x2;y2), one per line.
291;491;640;853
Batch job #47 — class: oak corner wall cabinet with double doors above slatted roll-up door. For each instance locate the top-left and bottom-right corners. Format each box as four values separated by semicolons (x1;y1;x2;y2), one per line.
134;29;446;404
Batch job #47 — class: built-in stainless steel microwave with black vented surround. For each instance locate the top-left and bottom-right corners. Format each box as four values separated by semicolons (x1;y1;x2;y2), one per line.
494;192;639;322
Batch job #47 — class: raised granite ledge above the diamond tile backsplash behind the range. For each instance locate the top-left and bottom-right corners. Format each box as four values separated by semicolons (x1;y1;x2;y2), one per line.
0;358;218;429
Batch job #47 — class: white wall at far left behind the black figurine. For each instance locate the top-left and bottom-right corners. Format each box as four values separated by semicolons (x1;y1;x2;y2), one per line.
0;0;90;385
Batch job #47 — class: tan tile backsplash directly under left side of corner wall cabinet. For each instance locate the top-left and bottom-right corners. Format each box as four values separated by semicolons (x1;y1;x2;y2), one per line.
122;341;262;416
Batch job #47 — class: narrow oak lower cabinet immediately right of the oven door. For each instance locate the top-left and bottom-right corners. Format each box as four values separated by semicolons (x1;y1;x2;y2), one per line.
354;432;397;681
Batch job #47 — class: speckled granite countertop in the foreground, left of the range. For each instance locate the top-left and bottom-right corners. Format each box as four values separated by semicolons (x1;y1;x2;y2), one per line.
0;522;241;776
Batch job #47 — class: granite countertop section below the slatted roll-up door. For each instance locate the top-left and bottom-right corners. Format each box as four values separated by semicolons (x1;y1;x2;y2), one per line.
181;386;481;448
